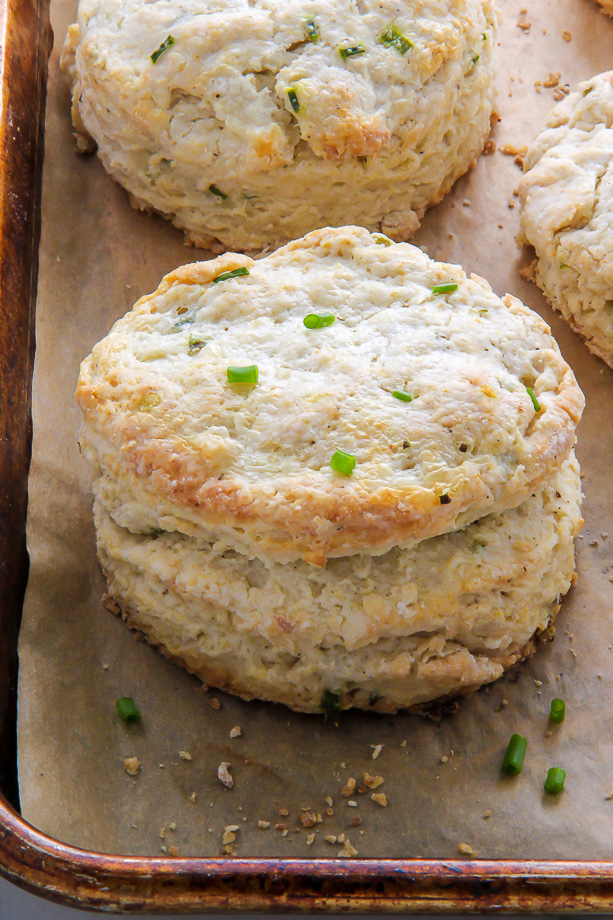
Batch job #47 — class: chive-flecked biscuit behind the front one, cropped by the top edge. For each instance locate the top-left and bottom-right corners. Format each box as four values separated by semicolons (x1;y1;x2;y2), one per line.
63;0;498;251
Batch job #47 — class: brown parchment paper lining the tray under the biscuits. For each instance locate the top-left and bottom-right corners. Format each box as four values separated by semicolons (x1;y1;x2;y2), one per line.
18;0;613;859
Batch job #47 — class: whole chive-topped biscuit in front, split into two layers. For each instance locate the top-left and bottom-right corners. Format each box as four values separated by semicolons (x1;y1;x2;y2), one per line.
77;227;583;712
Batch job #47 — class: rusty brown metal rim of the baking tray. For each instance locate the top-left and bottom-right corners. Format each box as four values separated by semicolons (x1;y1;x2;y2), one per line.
0;0;613;913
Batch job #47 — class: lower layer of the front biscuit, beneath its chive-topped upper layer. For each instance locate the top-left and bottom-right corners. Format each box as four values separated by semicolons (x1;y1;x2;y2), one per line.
95;455;581;712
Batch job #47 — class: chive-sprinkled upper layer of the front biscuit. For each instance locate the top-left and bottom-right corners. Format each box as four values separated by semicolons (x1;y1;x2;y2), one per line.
77;227;583;564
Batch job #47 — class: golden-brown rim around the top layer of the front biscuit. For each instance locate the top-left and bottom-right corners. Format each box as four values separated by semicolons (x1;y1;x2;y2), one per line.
75;227;584;565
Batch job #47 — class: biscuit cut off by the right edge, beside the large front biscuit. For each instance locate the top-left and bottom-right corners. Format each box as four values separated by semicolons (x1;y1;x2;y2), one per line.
520;71;613;367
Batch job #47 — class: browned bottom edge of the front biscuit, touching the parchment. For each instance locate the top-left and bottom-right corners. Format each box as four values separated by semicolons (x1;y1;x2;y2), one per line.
103;594;561;715
